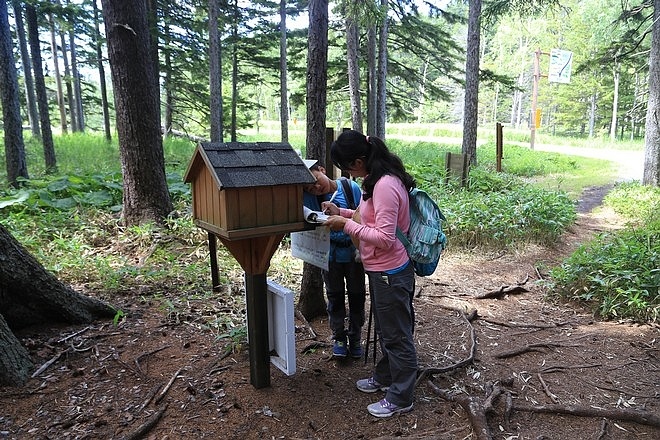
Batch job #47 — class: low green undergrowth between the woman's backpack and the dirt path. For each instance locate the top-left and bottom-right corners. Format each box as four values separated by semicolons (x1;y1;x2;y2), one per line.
389;140;576;248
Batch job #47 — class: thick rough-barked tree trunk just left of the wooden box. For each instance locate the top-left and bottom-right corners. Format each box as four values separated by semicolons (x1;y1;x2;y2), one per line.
102;0;173;225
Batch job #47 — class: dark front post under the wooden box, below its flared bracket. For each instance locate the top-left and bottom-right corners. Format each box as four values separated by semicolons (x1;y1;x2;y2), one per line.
245;273;270;388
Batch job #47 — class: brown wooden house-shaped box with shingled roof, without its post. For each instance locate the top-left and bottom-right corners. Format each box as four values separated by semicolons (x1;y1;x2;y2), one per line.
184;142;314;240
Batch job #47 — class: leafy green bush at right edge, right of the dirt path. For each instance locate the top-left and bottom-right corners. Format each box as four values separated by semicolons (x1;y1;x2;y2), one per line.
551;221;660;322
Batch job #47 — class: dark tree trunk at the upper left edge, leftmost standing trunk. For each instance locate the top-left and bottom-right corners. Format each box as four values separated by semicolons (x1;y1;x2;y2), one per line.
0;1;28;187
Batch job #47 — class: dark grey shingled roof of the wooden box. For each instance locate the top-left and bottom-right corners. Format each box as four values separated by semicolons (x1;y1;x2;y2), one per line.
184;142;315;188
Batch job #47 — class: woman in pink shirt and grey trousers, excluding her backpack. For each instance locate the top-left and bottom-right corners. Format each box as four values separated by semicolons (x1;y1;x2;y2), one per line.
323;130;417;417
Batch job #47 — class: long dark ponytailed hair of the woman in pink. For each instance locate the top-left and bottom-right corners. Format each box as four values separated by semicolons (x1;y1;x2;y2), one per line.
330;130;417;200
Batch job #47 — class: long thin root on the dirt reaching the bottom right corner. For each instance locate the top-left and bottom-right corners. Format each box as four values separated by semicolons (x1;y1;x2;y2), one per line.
512;404;660;428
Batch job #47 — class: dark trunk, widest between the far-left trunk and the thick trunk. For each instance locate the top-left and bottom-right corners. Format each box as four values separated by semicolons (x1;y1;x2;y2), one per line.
25;3;57;173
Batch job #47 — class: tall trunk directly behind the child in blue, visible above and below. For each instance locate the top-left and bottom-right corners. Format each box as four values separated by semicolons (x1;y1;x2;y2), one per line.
298;0;328;319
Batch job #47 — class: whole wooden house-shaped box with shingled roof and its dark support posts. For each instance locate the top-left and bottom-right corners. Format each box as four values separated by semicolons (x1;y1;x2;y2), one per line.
184;142;315;388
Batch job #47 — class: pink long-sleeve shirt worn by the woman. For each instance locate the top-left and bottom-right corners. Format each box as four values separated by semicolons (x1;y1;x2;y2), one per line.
340;175;410;272
